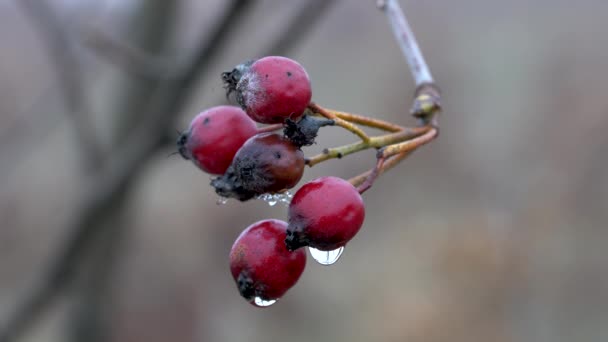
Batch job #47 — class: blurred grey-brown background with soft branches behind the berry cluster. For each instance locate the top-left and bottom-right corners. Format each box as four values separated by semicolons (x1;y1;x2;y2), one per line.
0;0;608;342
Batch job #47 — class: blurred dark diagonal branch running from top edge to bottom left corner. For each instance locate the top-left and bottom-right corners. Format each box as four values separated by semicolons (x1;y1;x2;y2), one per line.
0;0;253;342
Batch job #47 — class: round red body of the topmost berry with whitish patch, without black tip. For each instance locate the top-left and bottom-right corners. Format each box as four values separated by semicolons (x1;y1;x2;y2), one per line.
230;56;312;124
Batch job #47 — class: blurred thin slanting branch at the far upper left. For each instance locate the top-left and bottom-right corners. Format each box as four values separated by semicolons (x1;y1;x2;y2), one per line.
16;0;103;169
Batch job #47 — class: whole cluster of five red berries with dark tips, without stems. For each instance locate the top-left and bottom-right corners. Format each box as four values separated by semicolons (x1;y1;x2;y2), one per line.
177;56;365;306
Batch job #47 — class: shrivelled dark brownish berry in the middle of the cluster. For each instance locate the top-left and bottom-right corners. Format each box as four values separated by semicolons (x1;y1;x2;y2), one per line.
211;133;305;201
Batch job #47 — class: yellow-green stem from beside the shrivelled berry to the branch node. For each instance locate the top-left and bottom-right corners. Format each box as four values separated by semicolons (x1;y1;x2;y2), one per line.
306;126;433;167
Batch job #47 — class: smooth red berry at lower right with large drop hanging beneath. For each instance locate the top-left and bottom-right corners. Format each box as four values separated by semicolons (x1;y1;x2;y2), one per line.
285;177;365;251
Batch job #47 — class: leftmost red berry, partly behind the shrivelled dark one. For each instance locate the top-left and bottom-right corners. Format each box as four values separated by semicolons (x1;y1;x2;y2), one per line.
177;106;257;174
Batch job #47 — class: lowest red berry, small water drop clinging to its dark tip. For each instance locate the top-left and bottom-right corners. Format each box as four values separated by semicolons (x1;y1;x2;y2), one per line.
230;220;306;303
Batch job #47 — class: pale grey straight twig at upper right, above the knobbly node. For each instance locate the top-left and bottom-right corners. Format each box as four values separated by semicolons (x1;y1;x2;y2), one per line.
378;0;435;86
